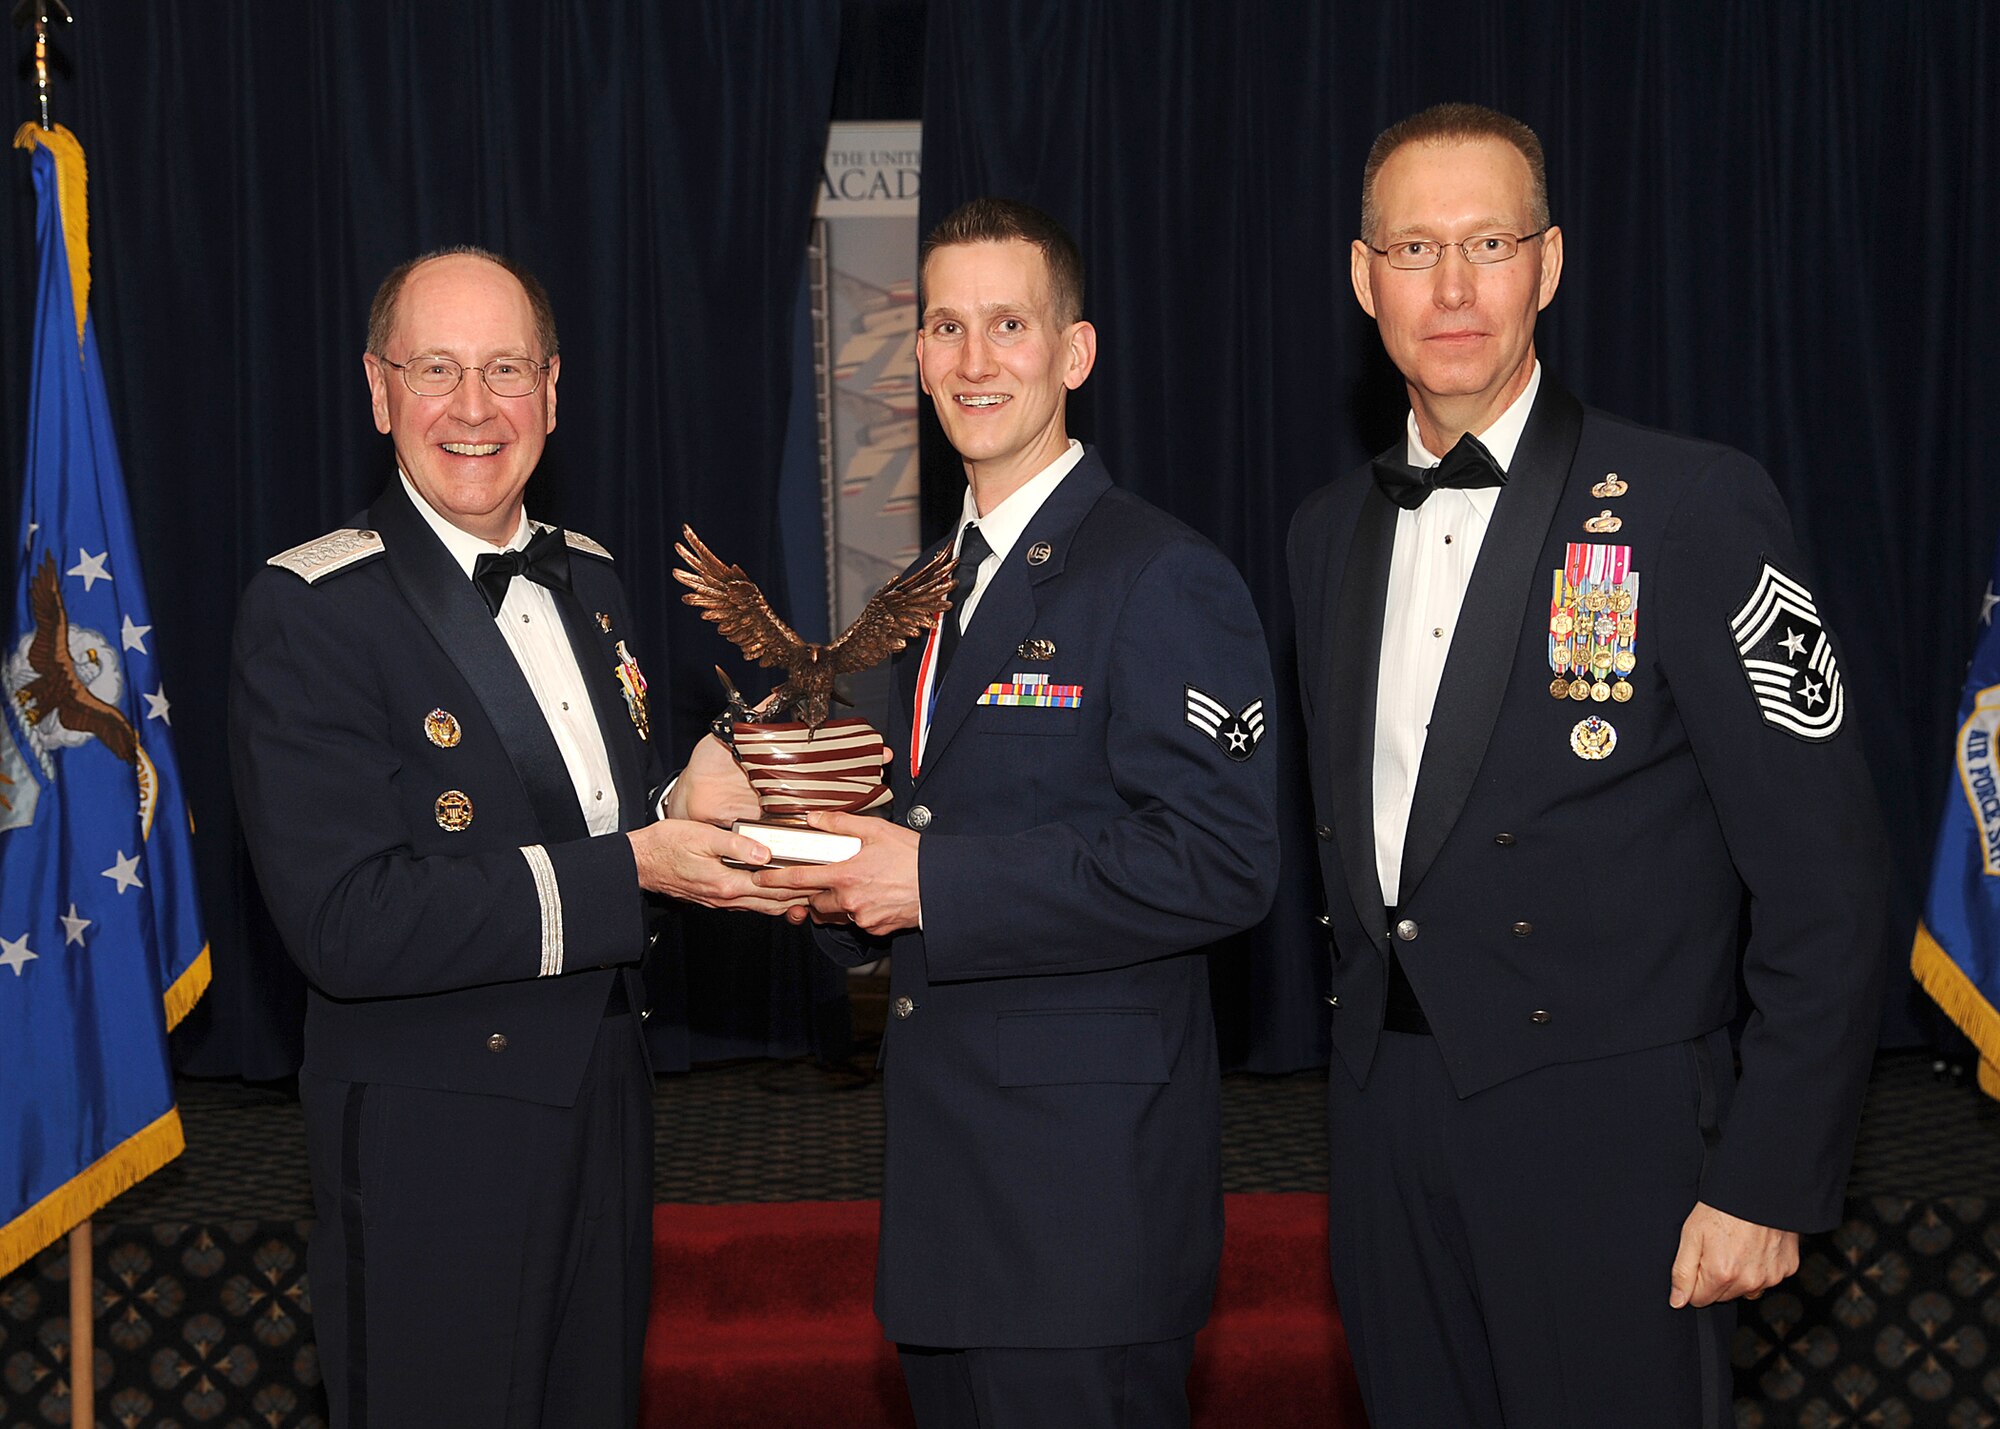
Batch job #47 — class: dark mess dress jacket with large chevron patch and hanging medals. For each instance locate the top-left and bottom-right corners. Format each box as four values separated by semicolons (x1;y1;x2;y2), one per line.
1290;374;1886;1232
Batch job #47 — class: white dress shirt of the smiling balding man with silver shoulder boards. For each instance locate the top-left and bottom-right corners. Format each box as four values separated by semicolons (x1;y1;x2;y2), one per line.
398;472;618;835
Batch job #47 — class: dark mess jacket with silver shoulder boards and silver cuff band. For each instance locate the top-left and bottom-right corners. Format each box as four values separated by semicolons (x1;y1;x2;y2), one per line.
230;482;662;1105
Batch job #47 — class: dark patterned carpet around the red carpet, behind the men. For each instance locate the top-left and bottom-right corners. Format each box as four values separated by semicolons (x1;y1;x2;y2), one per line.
0;1055;2000;1429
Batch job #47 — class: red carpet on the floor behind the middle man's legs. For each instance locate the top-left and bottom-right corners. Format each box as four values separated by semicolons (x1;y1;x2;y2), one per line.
640;1195;1366;1429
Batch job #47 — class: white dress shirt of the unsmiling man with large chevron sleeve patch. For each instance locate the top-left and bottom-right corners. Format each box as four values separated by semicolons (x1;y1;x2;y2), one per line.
1374;362;1542;907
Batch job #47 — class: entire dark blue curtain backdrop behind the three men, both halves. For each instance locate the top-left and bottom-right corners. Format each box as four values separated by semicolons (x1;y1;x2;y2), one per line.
0;0;2000;1077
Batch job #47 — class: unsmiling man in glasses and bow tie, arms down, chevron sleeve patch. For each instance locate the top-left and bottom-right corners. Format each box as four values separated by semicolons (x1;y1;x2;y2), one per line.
1290;104;1886;1429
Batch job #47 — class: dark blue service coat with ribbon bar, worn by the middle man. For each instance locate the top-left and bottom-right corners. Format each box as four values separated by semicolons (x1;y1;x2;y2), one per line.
822;450;1278;1347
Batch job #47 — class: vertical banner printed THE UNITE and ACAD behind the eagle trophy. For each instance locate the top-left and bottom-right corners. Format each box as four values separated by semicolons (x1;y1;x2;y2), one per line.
810;122;924;729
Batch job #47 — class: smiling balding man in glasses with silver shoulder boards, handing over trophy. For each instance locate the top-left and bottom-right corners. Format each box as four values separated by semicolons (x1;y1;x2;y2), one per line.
230;250;782;1429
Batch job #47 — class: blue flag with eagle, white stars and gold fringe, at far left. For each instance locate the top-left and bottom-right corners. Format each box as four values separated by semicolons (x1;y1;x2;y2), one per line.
0;124;208;1275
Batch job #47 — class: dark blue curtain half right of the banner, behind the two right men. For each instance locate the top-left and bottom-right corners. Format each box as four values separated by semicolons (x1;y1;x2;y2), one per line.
924;0;2000;1071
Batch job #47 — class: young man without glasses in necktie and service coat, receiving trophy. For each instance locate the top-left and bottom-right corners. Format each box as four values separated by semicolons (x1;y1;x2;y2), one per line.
756;198;1278;1429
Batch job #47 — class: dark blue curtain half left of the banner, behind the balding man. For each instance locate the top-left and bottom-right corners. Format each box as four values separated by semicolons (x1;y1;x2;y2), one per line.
0;0;846;1079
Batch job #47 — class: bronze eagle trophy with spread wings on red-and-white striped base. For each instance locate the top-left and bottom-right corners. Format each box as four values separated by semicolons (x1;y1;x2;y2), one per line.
674;526;958;853
